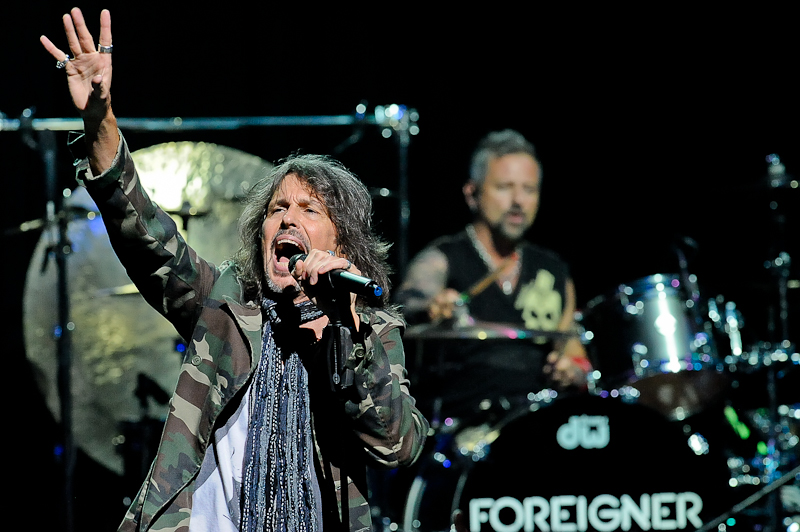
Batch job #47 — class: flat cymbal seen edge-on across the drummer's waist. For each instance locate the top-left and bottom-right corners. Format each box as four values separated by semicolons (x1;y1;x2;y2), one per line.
404;321;574;342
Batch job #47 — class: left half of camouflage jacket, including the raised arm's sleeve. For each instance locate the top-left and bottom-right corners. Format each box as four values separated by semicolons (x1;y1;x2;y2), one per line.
83;136;253;532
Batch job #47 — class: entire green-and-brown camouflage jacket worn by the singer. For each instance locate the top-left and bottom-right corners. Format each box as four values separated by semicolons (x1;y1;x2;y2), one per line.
79;135;428;532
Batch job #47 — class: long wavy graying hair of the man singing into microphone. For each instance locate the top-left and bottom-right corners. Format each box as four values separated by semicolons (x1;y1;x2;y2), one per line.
235;155;391;307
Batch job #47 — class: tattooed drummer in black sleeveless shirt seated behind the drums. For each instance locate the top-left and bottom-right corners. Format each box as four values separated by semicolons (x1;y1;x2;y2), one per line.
397;129;591;420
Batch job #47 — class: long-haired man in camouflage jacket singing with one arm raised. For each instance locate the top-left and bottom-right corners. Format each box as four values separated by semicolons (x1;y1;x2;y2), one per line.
41;8;428;532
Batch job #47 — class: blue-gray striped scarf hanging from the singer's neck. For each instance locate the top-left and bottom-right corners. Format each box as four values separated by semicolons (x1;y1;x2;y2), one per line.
241;299;322;532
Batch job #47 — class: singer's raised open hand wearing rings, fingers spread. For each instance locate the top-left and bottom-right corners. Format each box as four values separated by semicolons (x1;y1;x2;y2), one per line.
39;7;112;123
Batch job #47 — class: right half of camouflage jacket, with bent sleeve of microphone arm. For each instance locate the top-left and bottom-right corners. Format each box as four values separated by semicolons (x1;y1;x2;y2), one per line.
307;308;429;532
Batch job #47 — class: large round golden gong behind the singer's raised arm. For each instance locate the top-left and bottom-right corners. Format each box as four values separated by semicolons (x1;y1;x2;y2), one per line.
23;142;271;474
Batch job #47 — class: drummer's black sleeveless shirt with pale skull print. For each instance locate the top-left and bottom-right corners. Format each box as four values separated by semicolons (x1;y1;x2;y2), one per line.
415;231;569;419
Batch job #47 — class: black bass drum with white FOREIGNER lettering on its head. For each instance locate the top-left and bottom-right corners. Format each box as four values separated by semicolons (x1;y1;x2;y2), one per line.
402;394;730;532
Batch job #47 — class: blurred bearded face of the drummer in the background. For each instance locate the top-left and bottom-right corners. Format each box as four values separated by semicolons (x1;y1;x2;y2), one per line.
473;153;541;242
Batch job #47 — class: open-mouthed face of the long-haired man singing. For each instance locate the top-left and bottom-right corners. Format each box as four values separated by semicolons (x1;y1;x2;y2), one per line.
262;174;336;292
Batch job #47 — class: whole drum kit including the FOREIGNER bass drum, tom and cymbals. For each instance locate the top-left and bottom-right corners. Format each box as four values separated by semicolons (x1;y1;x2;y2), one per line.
374;159;800;532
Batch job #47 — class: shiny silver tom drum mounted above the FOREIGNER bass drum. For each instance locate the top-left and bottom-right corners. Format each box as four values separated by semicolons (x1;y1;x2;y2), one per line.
581;274;730;419
